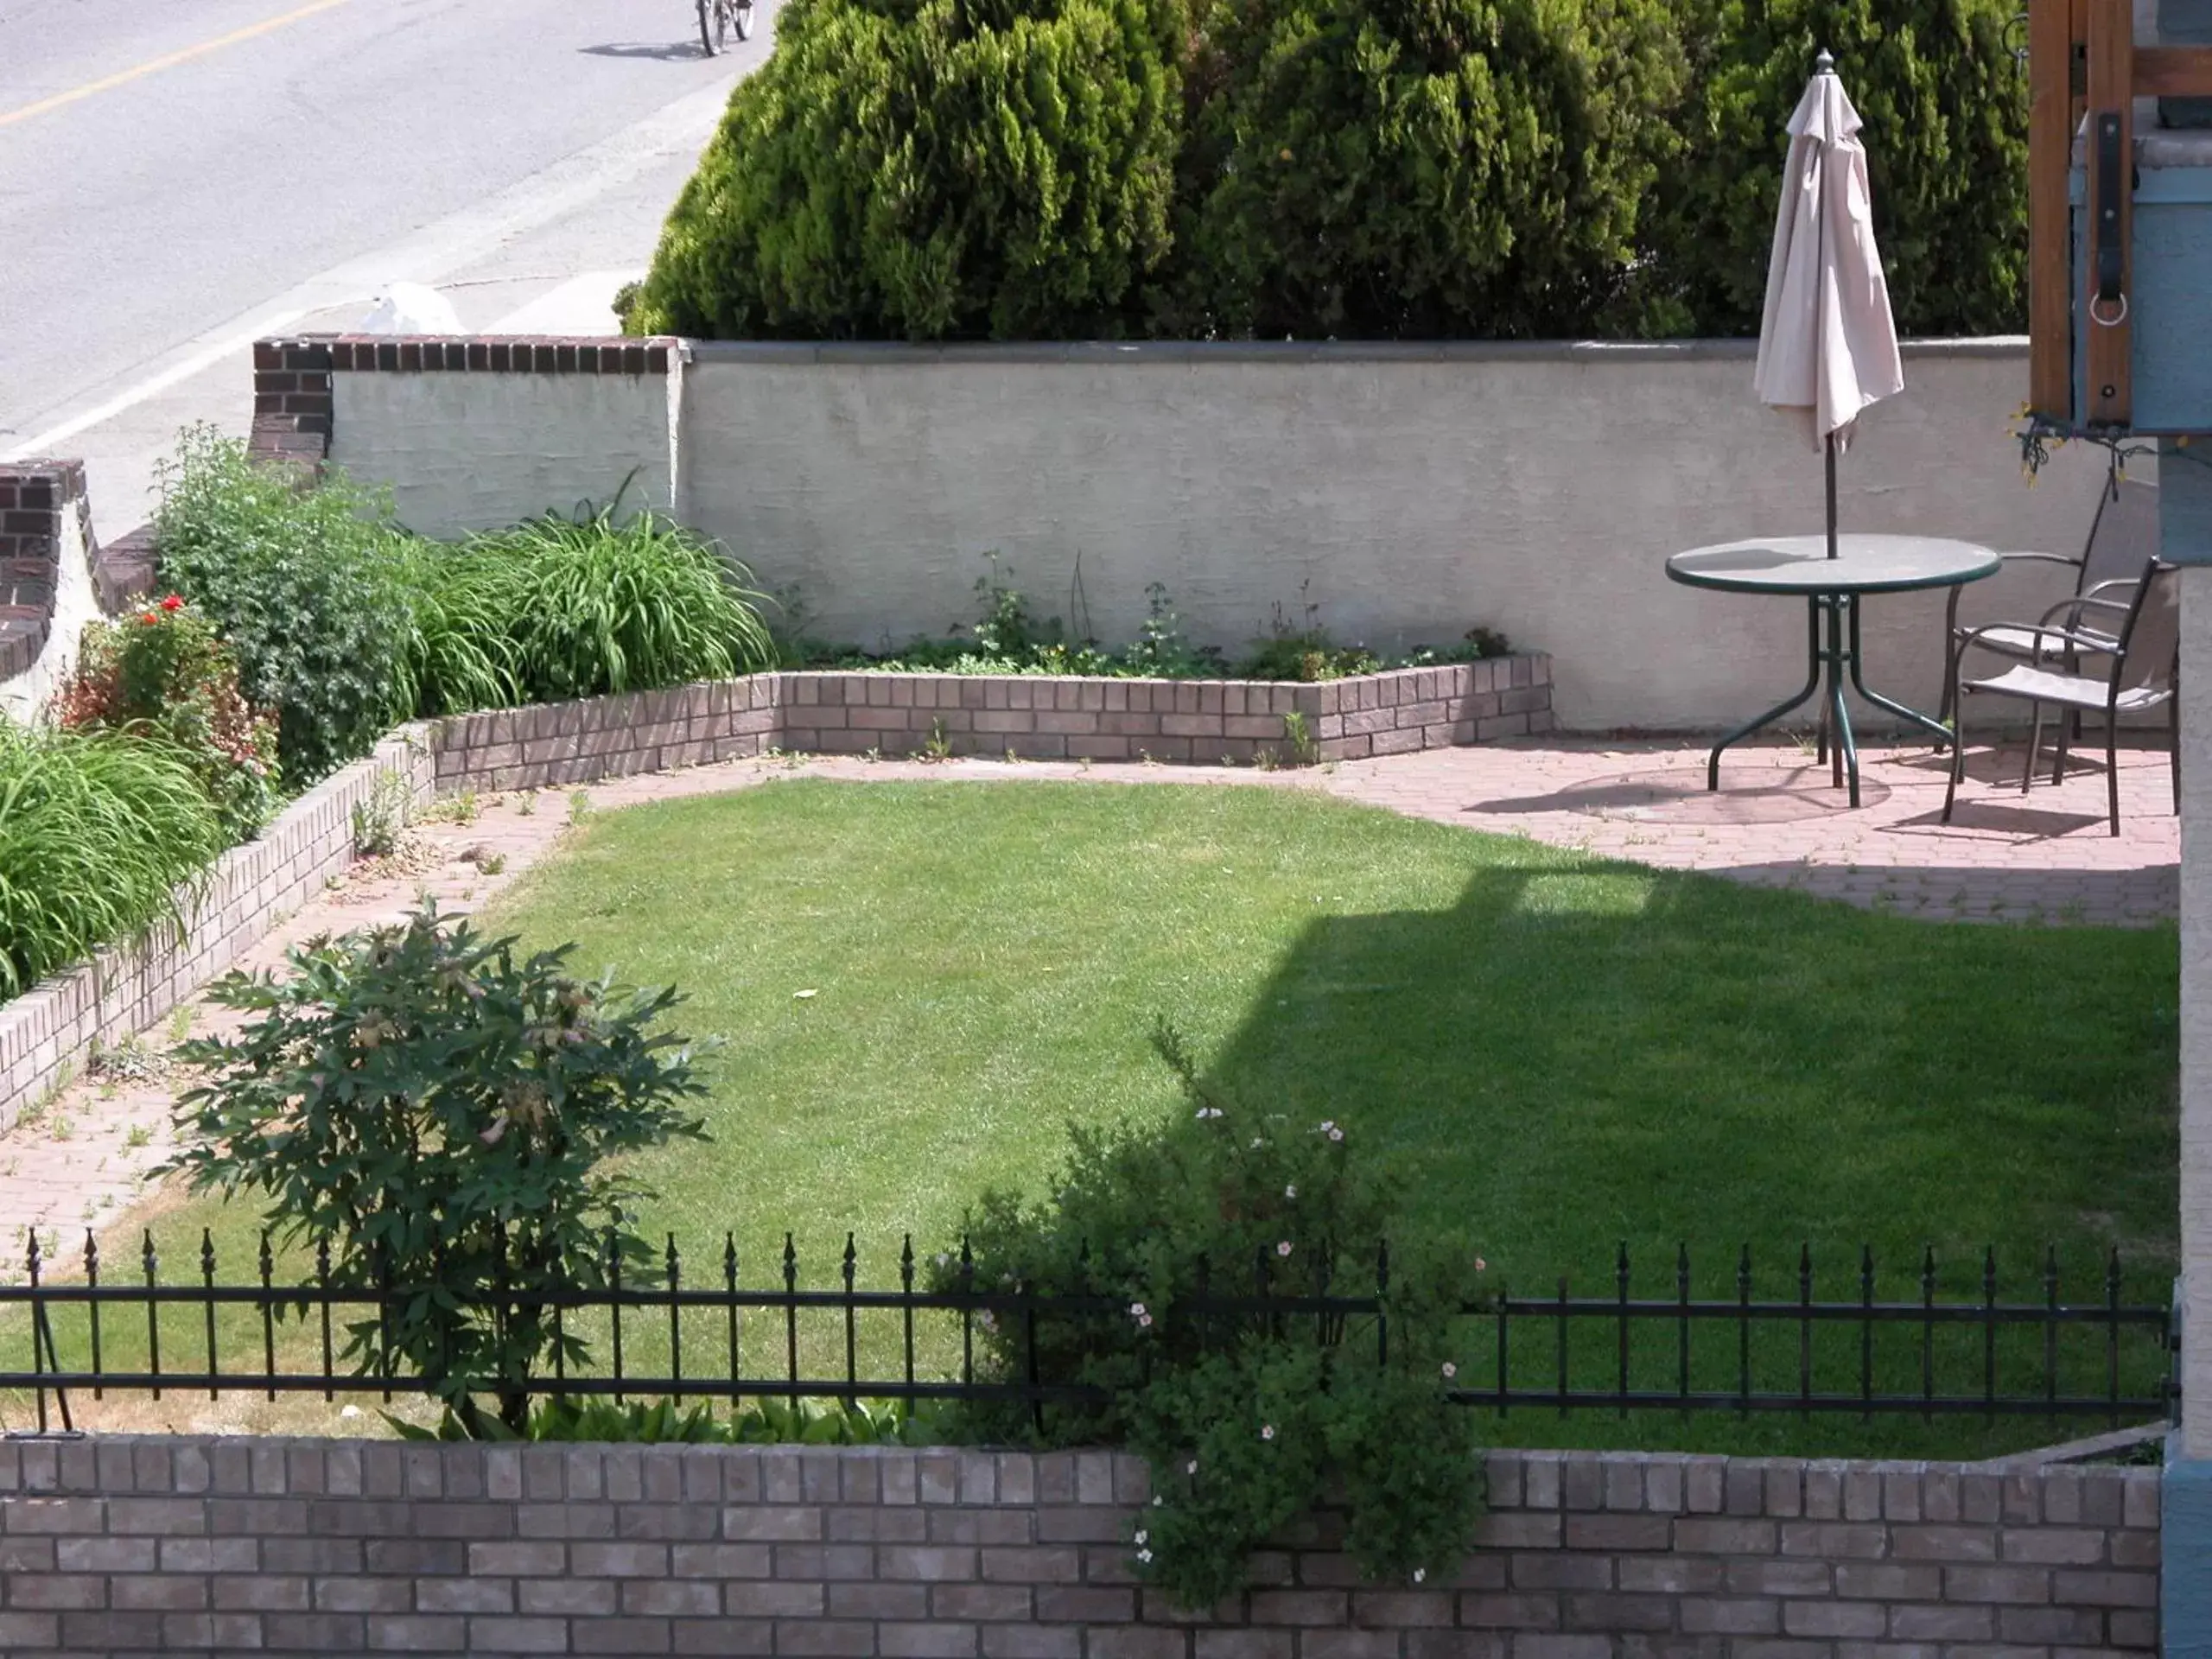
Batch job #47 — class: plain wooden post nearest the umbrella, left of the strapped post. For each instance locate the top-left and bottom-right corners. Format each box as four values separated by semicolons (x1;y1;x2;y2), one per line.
2029;0;2079;423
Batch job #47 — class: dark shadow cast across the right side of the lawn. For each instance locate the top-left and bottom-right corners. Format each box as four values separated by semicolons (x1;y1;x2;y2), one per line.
1208;865;2177;1455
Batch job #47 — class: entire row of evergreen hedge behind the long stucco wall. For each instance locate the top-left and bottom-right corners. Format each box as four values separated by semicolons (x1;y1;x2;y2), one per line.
626;0;2026;340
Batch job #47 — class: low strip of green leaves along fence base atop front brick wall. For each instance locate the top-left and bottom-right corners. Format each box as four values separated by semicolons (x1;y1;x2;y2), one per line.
387;1395;931;1446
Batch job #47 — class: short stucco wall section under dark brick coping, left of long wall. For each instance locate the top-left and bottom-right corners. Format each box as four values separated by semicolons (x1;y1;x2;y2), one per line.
329;372;672;537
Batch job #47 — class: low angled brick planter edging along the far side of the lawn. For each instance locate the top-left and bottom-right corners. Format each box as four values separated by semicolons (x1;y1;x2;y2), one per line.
417;655;1551;790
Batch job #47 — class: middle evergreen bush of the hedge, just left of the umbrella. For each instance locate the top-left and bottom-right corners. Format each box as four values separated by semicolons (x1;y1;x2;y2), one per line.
1164;0;1681;339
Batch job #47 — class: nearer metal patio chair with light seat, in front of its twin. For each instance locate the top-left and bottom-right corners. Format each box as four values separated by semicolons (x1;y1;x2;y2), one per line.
1942;560;2181;836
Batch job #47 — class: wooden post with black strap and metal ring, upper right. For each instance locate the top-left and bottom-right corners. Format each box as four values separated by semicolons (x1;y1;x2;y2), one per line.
2079;0;2134;427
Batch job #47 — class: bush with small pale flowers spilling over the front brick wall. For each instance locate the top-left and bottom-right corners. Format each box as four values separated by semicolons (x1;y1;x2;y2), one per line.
933;1028;1482;1608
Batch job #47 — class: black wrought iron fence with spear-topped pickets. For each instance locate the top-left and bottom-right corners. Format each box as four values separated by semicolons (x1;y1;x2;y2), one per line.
0;1234;2179;1431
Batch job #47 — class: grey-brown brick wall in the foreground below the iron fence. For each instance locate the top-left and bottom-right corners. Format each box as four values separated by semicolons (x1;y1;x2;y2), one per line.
0;1435;2159;1659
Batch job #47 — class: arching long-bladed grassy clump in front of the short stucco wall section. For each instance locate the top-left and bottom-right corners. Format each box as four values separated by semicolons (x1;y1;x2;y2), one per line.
407;506;777;715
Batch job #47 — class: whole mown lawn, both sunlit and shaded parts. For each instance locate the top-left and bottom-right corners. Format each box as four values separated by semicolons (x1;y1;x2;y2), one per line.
42;781;2177;1453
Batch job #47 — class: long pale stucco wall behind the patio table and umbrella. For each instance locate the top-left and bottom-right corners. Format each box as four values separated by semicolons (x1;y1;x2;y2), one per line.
672;343;2101;730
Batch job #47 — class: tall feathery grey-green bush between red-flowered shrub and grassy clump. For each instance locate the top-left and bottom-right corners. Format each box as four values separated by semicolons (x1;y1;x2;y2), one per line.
155;427;411;783
